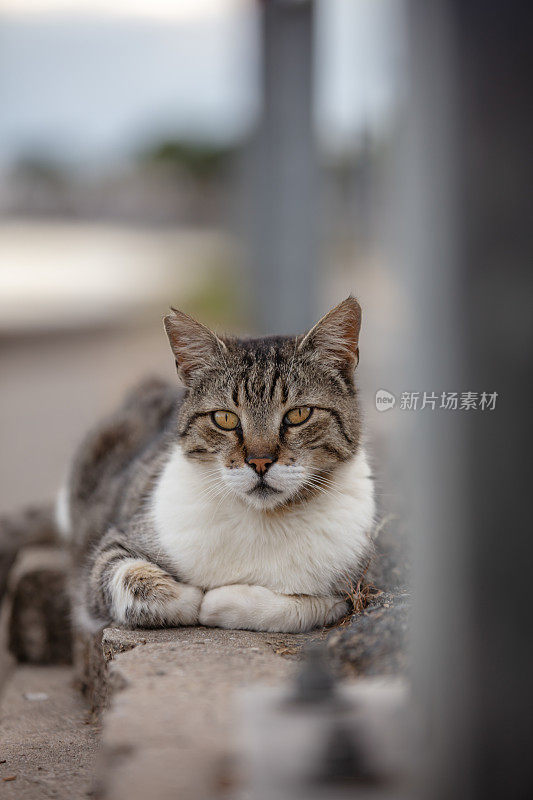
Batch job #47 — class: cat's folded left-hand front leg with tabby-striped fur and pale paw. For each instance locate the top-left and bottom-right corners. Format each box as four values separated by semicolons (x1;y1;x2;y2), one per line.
88;535;203;628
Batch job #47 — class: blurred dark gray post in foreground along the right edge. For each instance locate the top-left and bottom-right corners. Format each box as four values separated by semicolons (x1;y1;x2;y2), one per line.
402;0;533;800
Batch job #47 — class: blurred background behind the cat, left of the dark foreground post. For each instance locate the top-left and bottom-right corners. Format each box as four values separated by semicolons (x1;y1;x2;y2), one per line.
0;0;405;511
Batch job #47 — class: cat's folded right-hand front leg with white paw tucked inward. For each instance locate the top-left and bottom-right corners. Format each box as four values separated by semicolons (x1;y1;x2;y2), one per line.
199;584;348;633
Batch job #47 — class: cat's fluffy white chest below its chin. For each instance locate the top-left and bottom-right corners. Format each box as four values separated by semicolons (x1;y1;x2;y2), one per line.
151;449;374;594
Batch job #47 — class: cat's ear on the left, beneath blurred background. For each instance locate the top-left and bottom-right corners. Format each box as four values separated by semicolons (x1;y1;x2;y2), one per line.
164;308;226;383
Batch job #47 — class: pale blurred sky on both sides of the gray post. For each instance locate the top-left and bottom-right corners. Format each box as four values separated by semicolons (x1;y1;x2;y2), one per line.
0;0;399;169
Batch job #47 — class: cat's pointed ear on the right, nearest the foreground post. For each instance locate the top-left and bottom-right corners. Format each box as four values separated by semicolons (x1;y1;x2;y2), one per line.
298;295;361;372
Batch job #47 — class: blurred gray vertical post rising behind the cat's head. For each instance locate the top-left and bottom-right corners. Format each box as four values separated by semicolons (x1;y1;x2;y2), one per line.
248;0;318;333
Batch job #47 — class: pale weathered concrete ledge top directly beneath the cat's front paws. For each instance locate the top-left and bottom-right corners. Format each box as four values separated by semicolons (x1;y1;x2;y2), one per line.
91;628;325;800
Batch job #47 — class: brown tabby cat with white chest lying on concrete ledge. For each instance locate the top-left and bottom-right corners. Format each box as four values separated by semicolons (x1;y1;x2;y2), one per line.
57;297;374;632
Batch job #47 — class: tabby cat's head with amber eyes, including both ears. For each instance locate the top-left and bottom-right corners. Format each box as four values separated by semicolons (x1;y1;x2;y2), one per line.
165;298;361;510
